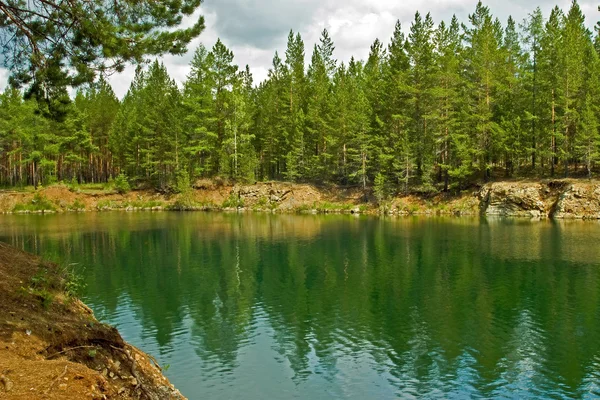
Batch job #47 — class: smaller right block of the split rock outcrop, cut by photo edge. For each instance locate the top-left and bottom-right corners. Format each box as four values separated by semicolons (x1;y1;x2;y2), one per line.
552;183;600;219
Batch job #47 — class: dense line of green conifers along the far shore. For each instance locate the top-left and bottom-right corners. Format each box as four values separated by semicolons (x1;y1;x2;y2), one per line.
0;1;600;193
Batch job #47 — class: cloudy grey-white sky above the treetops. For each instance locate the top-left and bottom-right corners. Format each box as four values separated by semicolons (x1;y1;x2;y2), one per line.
0;0;600;98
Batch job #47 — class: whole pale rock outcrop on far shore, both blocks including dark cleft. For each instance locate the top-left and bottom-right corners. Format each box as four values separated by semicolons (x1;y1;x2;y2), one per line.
479;180;600;219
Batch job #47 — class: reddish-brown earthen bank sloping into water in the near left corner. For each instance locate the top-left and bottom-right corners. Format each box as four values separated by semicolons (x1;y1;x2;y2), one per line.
0;243;184;399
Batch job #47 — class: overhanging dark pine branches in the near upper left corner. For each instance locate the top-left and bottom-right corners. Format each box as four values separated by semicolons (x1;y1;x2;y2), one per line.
0;0;204;112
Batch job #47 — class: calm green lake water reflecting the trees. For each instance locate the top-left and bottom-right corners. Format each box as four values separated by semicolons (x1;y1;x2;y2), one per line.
0;212;600;399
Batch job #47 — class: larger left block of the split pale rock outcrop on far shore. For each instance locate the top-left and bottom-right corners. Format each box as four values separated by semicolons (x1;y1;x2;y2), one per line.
479;182;549;218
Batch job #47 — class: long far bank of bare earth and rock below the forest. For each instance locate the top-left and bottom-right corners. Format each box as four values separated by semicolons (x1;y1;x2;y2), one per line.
0;179;600;219
